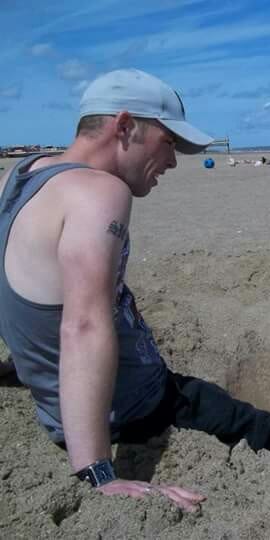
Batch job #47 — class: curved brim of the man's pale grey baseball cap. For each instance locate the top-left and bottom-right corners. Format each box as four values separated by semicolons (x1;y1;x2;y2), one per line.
159;118;214;154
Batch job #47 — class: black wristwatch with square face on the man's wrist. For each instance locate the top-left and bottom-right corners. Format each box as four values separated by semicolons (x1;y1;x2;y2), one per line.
76;459;116;487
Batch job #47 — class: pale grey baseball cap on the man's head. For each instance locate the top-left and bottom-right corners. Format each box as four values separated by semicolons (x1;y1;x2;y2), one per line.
80;69;213;154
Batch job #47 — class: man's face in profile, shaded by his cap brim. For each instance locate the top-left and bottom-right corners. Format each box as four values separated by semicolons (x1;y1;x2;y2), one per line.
118;117;177;197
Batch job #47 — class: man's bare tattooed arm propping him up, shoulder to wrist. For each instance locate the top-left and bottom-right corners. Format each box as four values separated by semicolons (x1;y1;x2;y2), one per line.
58;174;131;470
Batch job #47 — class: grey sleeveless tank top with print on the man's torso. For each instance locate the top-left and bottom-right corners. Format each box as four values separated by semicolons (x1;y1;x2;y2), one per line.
0;155;167;442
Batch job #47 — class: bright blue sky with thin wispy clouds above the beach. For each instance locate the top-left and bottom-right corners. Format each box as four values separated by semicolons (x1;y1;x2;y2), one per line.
0;0;270;147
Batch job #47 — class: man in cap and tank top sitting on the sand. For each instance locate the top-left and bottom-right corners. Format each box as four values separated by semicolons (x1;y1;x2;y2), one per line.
0;70;270;511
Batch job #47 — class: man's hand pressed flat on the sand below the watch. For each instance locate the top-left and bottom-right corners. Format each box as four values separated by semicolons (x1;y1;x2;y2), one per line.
97;479;206;512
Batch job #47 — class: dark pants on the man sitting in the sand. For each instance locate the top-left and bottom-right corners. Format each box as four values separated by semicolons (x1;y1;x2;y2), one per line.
113;371;270;451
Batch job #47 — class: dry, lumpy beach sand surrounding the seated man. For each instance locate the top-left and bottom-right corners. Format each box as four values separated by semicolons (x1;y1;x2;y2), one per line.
0;154;270;540
